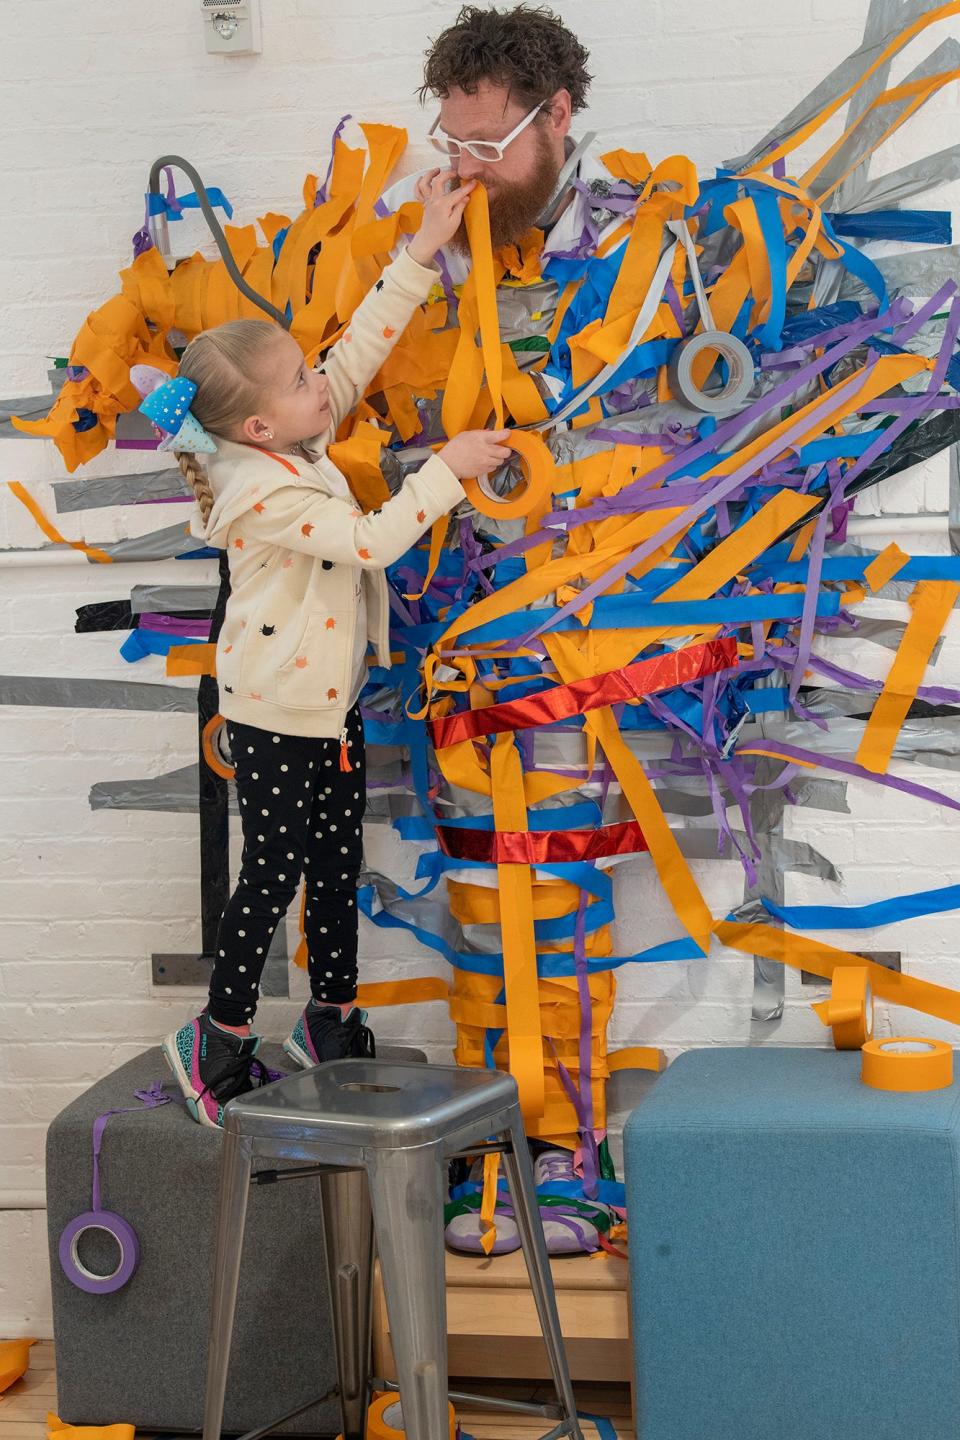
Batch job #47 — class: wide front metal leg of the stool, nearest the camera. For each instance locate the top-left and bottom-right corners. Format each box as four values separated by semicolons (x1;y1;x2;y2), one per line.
367;1145;450;1440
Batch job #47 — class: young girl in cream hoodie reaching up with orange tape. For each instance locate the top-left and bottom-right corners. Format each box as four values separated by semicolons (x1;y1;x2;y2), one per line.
154;171;510;1125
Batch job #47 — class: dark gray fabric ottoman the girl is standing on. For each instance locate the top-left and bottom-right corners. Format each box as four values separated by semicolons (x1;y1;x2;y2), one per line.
46;1045;423;1436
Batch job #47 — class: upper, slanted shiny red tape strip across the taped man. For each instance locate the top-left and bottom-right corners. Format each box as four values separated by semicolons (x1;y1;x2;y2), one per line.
430;636;737;750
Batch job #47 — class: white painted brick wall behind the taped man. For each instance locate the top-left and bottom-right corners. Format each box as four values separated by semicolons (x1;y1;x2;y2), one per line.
0;0;960;1333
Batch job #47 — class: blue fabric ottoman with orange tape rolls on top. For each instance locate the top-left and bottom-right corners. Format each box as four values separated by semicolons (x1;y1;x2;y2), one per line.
623;1048;960;1440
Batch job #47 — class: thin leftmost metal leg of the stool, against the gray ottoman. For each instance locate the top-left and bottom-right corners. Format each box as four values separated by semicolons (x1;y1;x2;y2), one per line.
203;1129;250;1440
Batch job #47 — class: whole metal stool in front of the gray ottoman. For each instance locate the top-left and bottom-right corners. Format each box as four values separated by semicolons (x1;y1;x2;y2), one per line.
203;1060;583;1440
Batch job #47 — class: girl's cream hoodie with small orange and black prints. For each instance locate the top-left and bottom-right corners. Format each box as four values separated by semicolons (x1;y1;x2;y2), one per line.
190;251;463;739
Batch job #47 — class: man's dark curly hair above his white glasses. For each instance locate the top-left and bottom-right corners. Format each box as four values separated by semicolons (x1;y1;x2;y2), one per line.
419;4;593;115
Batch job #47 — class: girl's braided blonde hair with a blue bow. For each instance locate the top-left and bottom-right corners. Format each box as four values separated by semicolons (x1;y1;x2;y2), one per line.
177;320;281;524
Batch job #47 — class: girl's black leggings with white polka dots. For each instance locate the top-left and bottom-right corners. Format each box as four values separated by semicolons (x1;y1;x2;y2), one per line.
210;706;367;1025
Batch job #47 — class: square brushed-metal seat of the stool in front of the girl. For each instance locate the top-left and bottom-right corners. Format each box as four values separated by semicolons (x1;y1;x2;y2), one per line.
223;1060;517;1155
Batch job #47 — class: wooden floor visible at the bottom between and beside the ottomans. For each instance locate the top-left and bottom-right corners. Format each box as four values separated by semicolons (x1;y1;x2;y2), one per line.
0;1341;633;1440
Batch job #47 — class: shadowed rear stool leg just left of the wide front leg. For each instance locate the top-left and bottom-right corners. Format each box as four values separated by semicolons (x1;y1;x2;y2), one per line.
320;1171;373;1440
